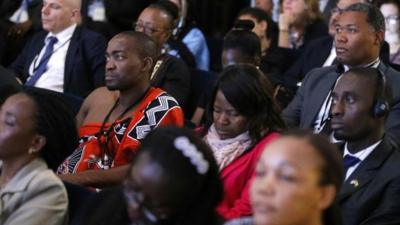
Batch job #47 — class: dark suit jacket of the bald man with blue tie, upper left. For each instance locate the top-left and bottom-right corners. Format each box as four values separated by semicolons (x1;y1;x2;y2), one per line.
10;26;106;97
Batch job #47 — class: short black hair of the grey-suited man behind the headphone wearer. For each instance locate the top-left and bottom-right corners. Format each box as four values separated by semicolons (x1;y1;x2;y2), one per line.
343;3;386;32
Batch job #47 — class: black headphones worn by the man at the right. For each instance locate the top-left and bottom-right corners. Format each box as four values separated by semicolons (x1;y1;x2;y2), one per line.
372;69;390;118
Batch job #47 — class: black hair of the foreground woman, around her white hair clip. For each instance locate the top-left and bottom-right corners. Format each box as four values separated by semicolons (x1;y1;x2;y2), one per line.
130;126;222;225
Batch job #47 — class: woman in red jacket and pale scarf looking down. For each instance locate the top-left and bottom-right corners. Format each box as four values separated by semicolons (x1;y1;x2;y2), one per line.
204;64;284;219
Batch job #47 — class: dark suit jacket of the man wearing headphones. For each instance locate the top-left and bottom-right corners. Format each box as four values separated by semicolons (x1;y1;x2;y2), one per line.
337;139;400;225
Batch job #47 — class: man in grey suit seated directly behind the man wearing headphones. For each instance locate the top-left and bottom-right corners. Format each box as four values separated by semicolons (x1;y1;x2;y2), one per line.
283;3;400;147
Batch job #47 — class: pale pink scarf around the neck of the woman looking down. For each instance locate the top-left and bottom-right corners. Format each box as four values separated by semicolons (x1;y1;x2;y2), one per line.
204;124;252;171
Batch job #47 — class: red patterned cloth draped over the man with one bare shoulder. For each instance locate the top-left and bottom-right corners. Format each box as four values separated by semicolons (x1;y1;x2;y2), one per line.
57;88;184;174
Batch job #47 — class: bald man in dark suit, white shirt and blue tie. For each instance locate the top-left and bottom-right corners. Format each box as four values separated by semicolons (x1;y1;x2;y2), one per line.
10;0;106;97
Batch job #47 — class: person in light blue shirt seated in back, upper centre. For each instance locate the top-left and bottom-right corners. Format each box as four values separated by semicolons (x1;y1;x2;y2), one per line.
168;0;210;71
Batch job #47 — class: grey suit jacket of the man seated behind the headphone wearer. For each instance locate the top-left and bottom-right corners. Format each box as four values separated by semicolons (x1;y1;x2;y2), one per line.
282;63;400;146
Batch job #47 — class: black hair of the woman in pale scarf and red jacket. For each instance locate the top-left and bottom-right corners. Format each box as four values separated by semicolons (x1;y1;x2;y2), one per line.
206;64;285;142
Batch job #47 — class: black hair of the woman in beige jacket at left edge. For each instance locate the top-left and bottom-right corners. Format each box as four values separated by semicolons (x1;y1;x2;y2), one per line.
20;87;78;171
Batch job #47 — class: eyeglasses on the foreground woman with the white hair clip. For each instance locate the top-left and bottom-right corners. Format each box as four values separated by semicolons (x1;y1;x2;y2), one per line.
123;181;158;223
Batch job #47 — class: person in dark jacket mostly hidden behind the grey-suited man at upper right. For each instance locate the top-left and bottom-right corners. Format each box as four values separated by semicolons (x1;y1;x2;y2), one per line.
282;0;389;95
